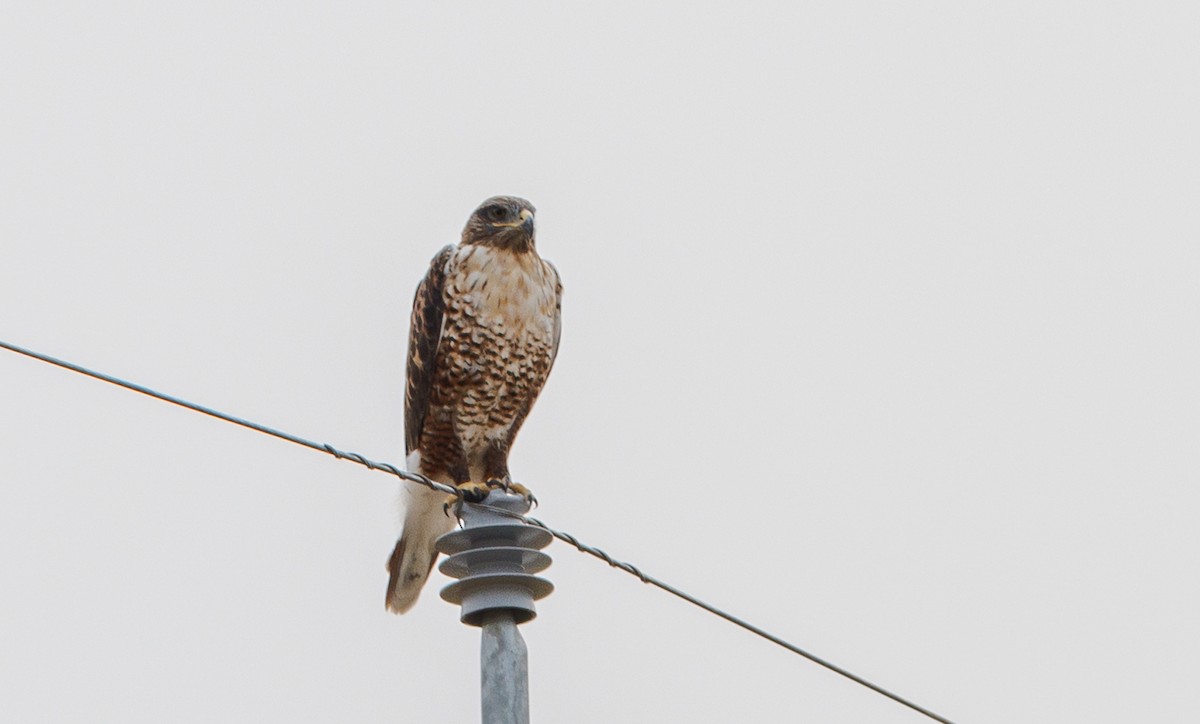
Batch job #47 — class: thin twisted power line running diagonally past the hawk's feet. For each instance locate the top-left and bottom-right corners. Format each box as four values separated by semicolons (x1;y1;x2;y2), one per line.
0;340;954;724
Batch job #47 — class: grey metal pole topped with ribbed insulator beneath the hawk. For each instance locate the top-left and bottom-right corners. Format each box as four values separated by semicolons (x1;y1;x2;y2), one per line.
437;491;554;724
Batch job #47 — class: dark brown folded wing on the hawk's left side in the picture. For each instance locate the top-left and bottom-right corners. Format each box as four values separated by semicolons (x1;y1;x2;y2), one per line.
404;246;455;455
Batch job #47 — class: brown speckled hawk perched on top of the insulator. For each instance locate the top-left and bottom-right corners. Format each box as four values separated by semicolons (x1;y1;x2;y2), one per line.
388;196;563;614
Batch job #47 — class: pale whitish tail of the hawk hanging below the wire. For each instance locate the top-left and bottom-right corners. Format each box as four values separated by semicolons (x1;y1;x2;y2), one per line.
388;477;454;614
